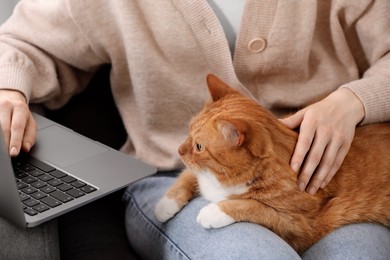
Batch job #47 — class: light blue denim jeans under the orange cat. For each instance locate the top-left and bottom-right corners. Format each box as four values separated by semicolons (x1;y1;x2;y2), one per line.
124;172;390;260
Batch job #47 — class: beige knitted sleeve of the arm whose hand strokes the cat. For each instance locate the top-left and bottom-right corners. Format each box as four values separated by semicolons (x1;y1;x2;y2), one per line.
342;0;390;124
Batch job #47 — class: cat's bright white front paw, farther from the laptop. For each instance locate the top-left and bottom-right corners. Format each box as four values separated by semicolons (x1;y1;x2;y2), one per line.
196;203;235;228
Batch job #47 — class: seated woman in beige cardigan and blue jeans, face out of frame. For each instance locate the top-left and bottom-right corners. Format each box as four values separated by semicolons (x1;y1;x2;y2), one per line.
0;0;390;259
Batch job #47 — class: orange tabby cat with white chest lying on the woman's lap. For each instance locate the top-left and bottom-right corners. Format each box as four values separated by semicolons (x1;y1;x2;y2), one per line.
155;75;390;253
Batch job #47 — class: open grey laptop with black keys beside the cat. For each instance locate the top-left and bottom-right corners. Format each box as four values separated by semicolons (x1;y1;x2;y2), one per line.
0;113;156;227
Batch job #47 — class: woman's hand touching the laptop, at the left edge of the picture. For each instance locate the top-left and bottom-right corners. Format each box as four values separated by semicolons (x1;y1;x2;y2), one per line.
0;90;37;156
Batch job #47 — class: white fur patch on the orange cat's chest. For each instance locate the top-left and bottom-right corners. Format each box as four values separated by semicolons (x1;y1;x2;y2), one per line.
197;172;248;202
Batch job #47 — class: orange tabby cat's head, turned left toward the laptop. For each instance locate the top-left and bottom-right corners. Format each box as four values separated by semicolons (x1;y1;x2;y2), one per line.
179;75;298;184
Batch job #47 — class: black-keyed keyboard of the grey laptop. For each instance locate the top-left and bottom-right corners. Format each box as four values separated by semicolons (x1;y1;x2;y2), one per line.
12;154;97;216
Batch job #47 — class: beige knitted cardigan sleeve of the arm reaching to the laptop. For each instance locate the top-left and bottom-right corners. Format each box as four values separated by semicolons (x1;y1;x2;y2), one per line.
0;0;103;107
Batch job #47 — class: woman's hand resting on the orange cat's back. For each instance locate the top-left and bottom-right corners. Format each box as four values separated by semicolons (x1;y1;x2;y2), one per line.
281;88;364;195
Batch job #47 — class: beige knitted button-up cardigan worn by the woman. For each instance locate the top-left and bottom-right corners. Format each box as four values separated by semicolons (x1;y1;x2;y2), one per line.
0;0;390;169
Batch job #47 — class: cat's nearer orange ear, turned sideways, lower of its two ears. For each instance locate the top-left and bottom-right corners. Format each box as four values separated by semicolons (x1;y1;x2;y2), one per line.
218;120;247;146
